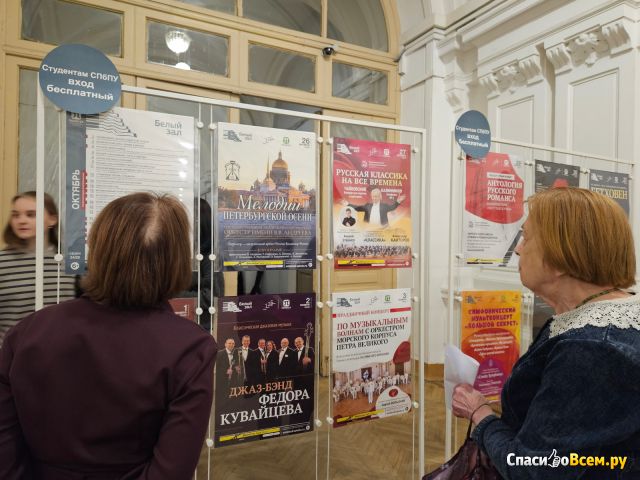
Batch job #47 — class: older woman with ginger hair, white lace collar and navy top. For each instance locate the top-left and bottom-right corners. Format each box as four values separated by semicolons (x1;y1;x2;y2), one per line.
453;187;640;480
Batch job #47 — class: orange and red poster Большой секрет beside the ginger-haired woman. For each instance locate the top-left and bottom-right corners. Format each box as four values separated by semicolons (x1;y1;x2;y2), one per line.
460;290;522;399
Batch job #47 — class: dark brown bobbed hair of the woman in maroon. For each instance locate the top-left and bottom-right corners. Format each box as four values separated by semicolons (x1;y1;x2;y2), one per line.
82;193;191;308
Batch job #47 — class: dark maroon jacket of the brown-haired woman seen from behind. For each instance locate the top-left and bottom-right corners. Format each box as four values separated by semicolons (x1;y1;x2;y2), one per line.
0;298;217;480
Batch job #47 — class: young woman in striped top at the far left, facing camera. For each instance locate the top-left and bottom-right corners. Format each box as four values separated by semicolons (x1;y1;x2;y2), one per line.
0;192;75;346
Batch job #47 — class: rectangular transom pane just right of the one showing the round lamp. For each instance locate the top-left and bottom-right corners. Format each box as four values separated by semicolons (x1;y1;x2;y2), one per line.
249;45;316;92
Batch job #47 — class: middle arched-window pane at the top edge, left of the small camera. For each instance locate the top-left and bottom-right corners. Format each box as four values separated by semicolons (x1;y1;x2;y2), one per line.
242;0;322;35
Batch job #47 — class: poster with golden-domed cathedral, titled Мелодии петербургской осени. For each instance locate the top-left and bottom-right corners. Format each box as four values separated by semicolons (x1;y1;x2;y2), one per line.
216;122;316;270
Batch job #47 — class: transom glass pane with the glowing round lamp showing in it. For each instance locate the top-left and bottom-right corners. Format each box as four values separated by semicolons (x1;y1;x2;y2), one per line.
147;22;229;77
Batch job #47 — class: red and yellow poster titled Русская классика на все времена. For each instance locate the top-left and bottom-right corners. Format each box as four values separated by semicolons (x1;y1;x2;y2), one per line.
333;138;411;268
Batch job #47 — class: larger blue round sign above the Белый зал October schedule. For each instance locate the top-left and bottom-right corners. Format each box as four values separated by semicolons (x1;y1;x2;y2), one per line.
39;45;122;114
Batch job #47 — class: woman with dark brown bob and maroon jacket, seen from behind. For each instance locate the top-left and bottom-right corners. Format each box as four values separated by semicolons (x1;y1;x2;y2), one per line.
0;193;216;480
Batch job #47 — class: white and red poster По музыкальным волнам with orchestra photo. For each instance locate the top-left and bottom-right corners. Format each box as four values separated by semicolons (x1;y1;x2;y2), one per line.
331;288;414;427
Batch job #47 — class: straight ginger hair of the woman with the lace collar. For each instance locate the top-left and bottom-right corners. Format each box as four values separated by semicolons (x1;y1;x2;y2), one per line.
528;187;636;288
